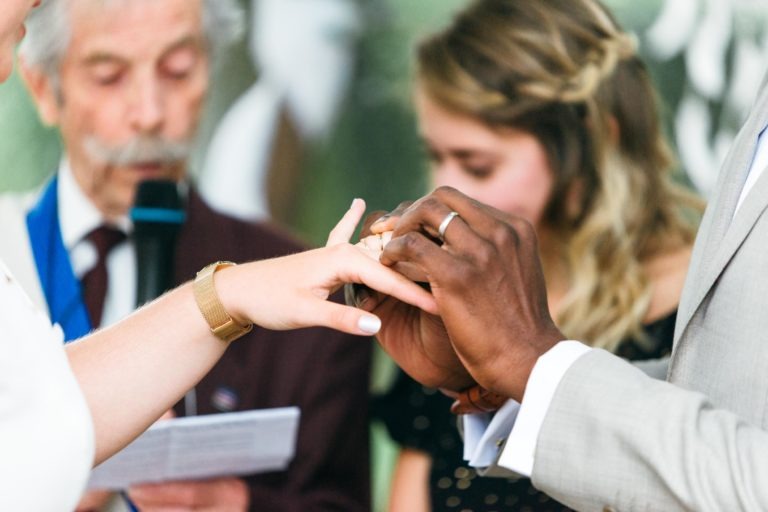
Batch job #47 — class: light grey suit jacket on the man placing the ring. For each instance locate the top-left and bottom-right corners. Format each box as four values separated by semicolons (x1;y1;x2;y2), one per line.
532;77;768;511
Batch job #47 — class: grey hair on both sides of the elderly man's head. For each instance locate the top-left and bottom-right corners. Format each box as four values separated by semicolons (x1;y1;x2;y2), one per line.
19;0;245;79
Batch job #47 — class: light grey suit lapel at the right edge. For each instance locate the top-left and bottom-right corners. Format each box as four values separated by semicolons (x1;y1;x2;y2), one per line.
673;83;768;348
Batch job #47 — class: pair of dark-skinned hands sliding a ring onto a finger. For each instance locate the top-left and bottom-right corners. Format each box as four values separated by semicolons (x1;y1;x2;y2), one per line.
359;187;564;401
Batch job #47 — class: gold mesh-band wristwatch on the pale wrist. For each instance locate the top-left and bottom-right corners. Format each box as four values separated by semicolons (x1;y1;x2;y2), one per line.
193;261;253;342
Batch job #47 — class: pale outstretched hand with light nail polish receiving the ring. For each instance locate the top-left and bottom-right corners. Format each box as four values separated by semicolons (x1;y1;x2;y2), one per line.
216;200;437;335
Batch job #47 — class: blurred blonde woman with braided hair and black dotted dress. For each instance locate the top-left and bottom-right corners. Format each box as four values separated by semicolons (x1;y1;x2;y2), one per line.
379;0;702;512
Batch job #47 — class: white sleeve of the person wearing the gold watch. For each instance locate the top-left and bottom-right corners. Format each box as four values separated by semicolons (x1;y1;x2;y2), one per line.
0;262;94;510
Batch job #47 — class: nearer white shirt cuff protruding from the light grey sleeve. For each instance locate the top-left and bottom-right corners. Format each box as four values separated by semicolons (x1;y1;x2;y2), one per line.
498;341;592;477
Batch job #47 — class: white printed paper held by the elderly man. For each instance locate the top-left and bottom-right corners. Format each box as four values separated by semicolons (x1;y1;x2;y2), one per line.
88;407;299;489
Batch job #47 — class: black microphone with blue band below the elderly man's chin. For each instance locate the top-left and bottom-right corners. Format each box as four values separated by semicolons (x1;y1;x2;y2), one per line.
130;180;186;306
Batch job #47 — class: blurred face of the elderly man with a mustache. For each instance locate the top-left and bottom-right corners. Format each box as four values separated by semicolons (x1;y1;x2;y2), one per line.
40;0;208;216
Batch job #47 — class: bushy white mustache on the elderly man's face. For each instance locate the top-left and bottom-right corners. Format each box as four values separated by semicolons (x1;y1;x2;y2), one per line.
84;136;192;166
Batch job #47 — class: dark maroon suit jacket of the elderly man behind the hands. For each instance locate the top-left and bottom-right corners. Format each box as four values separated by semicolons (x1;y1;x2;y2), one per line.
168;190;372;512
